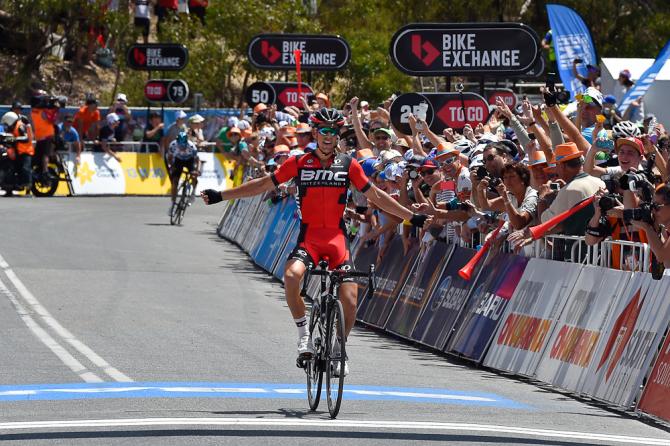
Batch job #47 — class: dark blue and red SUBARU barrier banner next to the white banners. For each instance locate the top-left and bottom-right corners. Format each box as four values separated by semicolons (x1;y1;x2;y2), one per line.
450;254;528;362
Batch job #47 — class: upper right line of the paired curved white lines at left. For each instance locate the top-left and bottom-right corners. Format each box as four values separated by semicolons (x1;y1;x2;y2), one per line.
0;255;133;382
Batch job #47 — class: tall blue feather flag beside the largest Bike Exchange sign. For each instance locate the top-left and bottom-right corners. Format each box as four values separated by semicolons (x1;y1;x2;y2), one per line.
547;5;597;98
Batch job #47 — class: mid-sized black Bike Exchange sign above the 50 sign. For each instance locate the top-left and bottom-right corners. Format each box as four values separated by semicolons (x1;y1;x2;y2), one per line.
247;34;351;71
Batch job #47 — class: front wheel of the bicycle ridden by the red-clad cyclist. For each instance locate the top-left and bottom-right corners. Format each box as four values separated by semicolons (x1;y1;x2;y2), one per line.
326;300;347;418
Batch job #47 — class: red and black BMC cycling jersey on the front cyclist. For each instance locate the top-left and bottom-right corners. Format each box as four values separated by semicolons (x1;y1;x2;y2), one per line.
271;152;371;229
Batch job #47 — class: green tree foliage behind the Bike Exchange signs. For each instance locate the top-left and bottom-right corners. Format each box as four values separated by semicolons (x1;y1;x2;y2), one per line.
0;0;670;106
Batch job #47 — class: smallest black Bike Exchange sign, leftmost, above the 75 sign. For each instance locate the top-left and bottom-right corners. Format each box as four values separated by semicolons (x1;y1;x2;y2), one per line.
126;43;188;71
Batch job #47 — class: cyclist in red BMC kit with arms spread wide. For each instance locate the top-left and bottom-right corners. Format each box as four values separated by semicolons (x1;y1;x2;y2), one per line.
201;108;427;375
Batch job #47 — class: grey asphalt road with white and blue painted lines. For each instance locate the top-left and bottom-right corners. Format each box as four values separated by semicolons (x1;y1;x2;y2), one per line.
0;197;670;445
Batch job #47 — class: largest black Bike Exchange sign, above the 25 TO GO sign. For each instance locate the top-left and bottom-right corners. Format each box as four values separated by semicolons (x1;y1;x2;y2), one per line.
390;23;540;76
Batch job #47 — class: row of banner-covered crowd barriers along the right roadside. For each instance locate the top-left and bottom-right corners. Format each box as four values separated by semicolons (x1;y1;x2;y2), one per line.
218;197;670;420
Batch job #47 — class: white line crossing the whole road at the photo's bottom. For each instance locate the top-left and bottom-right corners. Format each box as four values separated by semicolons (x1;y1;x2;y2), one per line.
0;418;670;446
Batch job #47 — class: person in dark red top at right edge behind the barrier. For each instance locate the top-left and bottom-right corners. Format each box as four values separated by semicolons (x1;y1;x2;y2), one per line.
631;184;670;268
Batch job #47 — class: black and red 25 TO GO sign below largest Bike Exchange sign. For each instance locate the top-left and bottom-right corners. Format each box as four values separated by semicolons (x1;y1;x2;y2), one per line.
391;92;489;135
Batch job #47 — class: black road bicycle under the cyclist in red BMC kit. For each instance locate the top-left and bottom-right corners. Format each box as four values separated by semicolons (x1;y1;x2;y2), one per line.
297;260;375;418
